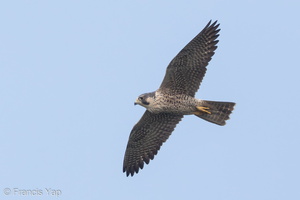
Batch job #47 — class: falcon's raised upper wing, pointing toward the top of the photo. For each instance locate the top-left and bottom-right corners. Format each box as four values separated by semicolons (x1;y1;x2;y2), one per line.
159;21;220;96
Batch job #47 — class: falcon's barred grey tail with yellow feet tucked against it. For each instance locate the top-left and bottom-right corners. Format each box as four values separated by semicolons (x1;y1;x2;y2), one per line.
193;100;235;126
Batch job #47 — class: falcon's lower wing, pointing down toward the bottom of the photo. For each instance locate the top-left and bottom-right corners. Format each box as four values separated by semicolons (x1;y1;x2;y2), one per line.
123;111;183;176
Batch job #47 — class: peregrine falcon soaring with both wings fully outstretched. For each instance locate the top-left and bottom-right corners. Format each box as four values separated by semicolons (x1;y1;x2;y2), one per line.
123;21;235;176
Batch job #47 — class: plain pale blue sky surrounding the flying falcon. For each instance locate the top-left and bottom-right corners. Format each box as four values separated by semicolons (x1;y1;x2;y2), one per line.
0;0;300;200
